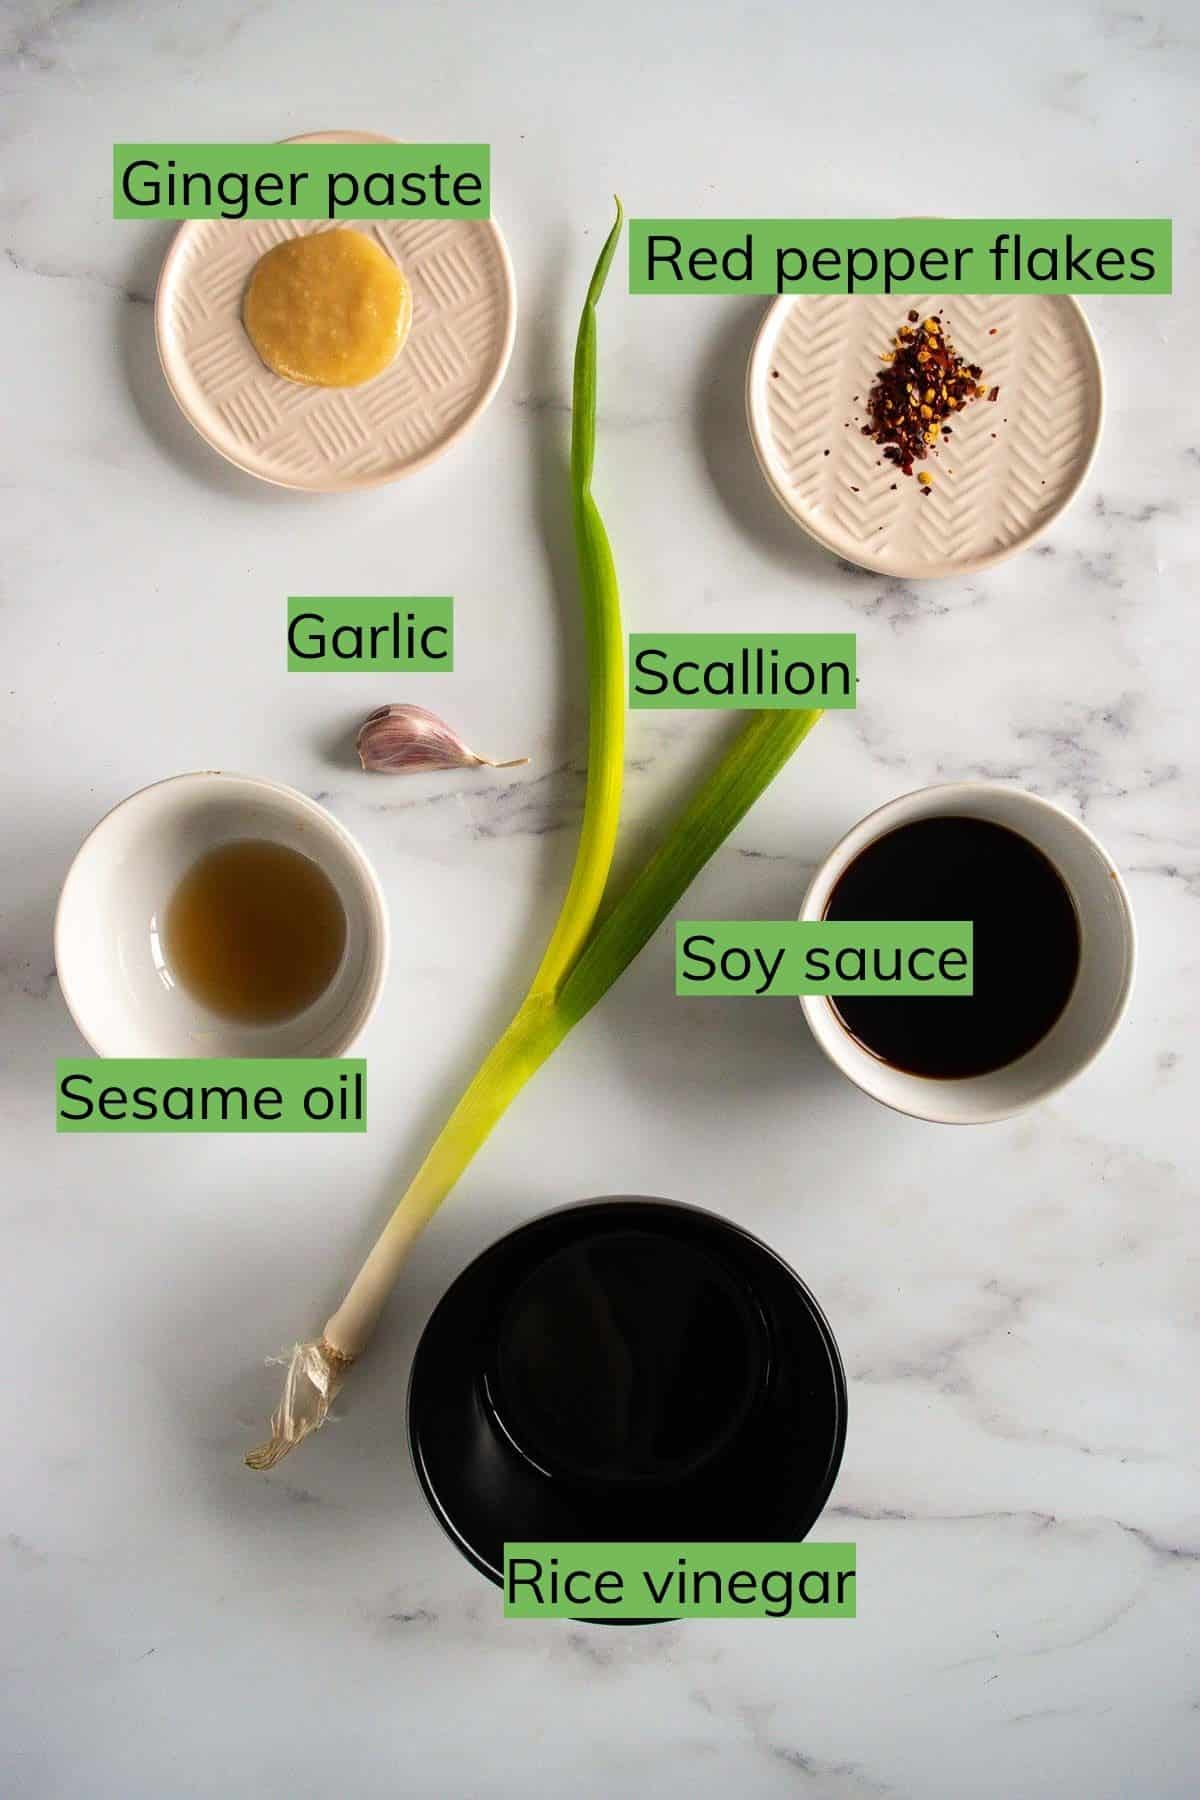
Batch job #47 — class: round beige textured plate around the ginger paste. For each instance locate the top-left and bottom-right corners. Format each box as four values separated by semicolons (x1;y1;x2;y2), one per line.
155;131;516;493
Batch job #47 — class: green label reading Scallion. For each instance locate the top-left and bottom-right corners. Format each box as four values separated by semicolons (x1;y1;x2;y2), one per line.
630;632;858;711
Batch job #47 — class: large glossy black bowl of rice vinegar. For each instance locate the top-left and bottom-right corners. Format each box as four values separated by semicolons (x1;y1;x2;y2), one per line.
408;1197;846;1584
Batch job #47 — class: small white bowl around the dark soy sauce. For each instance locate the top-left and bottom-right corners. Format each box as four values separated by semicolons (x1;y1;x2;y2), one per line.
801;781;1137;1125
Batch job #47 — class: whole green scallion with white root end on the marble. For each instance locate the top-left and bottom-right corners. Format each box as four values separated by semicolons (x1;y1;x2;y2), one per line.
246;202;820;1469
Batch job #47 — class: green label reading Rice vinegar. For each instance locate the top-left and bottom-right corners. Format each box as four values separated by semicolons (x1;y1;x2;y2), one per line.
504;1543;858;1620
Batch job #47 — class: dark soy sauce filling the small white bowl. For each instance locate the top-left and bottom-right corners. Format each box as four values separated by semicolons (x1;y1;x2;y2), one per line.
824;814;1079;1080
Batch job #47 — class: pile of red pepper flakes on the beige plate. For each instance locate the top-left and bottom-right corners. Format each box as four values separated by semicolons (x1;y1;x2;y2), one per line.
862;311;1000;495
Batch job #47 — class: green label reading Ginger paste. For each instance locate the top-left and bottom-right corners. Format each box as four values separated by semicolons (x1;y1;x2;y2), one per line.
113;144;491;220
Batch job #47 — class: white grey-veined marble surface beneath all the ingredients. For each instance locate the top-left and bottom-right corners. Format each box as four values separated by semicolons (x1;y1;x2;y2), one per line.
0;0;1200;1800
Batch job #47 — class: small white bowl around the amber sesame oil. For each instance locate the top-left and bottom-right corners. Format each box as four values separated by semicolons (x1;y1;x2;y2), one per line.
54;770;389;1057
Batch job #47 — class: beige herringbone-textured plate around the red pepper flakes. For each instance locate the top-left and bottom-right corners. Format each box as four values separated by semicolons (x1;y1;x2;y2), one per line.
747;293;1103;578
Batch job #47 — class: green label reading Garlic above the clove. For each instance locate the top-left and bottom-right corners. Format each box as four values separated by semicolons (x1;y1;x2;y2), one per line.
288;594;453;675
